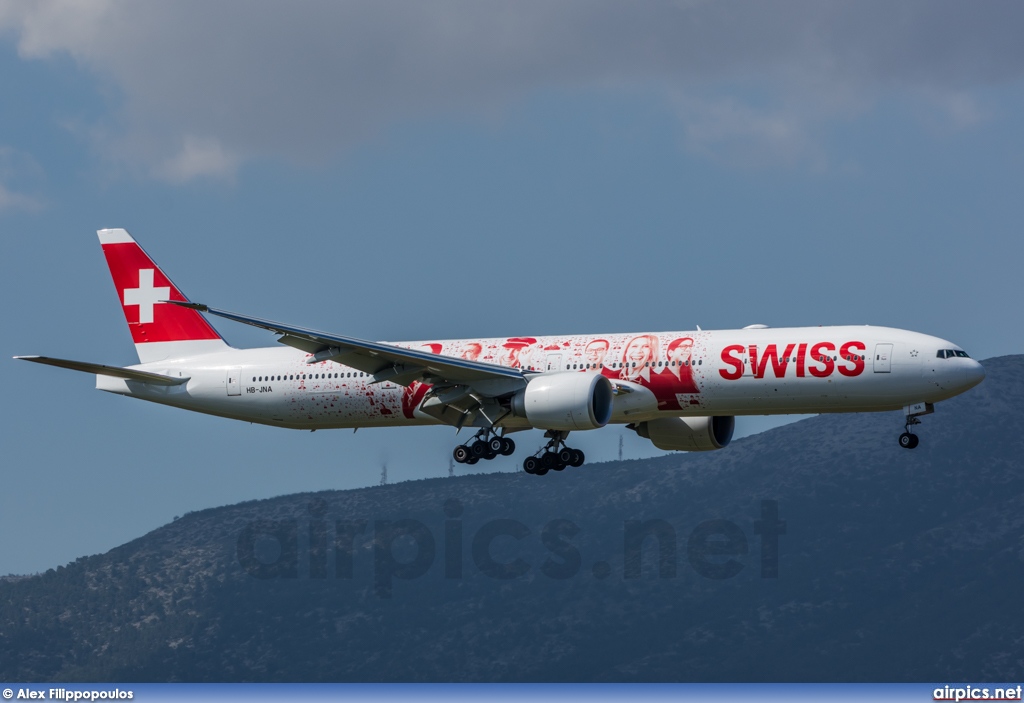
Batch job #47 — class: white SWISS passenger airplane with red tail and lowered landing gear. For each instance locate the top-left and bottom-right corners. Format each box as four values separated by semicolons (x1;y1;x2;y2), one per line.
14;229;985;476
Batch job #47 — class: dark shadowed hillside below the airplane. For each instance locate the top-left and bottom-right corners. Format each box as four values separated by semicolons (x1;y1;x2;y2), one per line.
0;356;1024;682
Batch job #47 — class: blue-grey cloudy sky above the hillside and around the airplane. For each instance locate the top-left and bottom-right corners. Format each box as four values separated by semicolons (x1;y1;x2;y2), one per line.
0;1;1024;573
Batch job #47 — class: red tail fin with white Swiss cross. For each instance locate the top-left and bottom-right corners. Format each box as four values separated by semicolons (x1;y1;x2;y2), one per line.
96;229;228;363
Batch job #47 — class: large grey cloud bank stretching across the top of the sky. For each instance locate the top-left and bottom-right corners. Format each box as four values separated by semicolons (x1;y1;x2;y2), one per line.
0;0;1024;181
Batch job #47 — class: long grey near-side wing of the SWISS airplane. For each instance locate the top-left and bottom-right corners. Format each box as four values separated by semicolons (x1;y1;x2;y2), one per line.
168;301;527;404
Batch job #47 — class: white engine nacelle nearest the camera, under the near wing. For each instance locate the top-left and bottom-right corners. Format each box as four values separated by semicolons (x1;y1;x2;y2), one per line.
512;371;612;431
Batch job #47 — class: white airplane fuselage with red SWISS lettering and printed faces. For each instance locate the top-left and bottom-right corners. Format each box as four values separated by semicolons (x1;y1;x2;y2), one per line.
96;325;984;430
